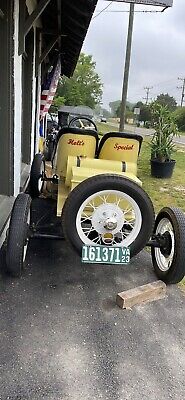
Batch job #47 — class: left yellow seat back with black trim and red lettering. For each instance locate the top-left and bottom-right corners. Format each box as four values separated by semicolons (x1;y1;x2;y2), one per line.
56;128;98;176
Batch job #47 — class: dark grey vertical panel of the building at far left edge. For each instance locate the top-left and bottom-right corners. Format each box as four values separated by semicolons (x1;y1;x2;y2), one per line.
0;0;14;196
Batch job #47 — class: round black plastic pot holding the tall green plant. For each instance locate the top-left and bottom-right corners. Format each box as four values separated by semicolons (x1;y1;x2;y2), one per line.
150;159;176;178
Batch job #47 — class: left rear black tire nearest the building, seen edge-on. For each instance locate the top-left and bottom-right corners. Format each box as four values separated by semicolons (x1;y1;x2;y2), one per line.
6;193;31;277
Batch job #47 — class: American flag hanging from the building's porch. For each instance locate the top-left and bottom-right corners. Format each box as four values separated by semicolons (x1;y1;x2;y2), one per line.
40;58;61;120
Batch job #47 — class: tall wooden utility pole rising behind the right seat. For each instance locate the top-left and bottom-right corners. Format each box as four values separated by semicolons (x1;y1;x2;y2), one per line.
119;3;134;132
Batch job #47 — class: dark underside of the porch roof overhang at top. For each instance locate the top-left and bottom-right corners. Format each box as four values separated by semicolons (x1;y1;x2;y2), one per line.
42;0;97;77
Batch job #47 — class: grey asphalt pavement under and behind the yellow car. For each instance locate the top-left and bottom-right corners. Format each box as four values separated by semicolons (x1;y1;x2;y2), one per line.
0;200;185;400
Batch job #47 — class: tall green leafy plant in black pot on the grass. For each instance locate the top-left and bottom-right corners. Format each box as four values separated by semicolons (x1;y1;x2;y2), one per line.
151;102;179;178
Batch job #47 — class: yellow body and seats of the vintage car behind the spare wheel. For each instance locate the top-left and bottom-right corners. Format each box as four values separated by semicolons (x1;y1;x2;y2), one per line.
50;133;142;218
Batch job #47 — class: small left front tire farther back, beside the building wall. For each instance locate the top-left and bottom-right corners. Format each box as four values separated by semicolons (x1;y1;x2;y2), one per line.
30;153;45;198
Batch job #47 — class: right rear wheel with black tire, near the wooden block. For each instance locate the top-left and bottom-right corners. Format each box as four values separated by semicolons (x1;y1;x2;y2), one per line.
151;207;185;283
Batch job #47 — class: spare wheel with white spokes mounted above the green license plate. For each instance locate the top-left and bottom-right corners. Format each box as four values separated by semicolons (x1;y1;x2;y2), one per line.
62;174;154;256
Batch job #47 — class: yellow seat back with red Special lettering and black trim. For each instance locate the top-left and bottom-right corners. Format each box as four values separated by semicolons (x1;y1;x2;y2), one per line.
98;132;143;164
